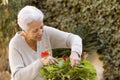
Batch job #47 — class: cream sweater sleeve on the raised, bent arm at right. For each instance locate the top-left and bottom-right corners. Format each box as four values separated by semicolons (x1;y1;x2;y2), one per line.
44;27;82;55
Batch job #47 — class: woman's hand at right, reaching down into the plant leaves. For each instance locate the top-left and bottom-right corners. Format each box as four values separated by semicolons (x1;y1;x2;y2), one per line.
70;51;81;67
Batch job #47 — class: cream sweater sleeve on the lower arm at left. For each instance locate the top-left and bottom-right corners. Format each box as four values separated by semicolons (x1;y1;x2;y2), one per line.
9;45;41;80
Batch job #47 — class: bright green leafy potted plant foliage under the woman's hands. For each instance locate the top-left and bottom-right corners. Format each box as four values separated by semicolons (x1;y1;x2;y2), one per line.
40;58;97;80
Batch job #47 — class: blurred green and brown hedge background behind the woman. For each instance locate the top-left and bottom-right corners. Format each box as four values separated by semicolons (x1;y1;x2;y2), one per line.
0;0;120;80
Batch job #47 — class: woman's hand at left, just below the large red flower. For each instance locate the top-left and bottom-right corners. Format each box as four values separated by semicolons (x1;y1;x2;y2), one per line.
41;56;58;66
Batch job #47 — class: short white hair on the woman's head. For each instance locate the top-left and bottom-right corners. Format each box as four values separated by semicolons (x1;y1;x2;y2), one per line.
17;6;44;31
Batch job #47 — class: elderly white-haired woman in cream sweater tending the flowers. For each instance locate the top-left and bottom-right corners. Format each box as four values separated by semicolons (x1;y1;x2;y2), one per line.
9;6;82;80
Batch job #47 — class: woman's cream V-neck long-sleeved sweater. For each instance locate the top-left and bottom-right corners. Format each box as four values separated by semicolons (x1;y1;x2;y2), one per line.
9;26;82;80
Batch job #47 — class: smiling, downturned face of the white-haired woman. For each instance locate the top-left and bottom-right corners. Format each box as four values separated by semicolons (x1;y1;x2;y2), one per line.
26;20;43;41
